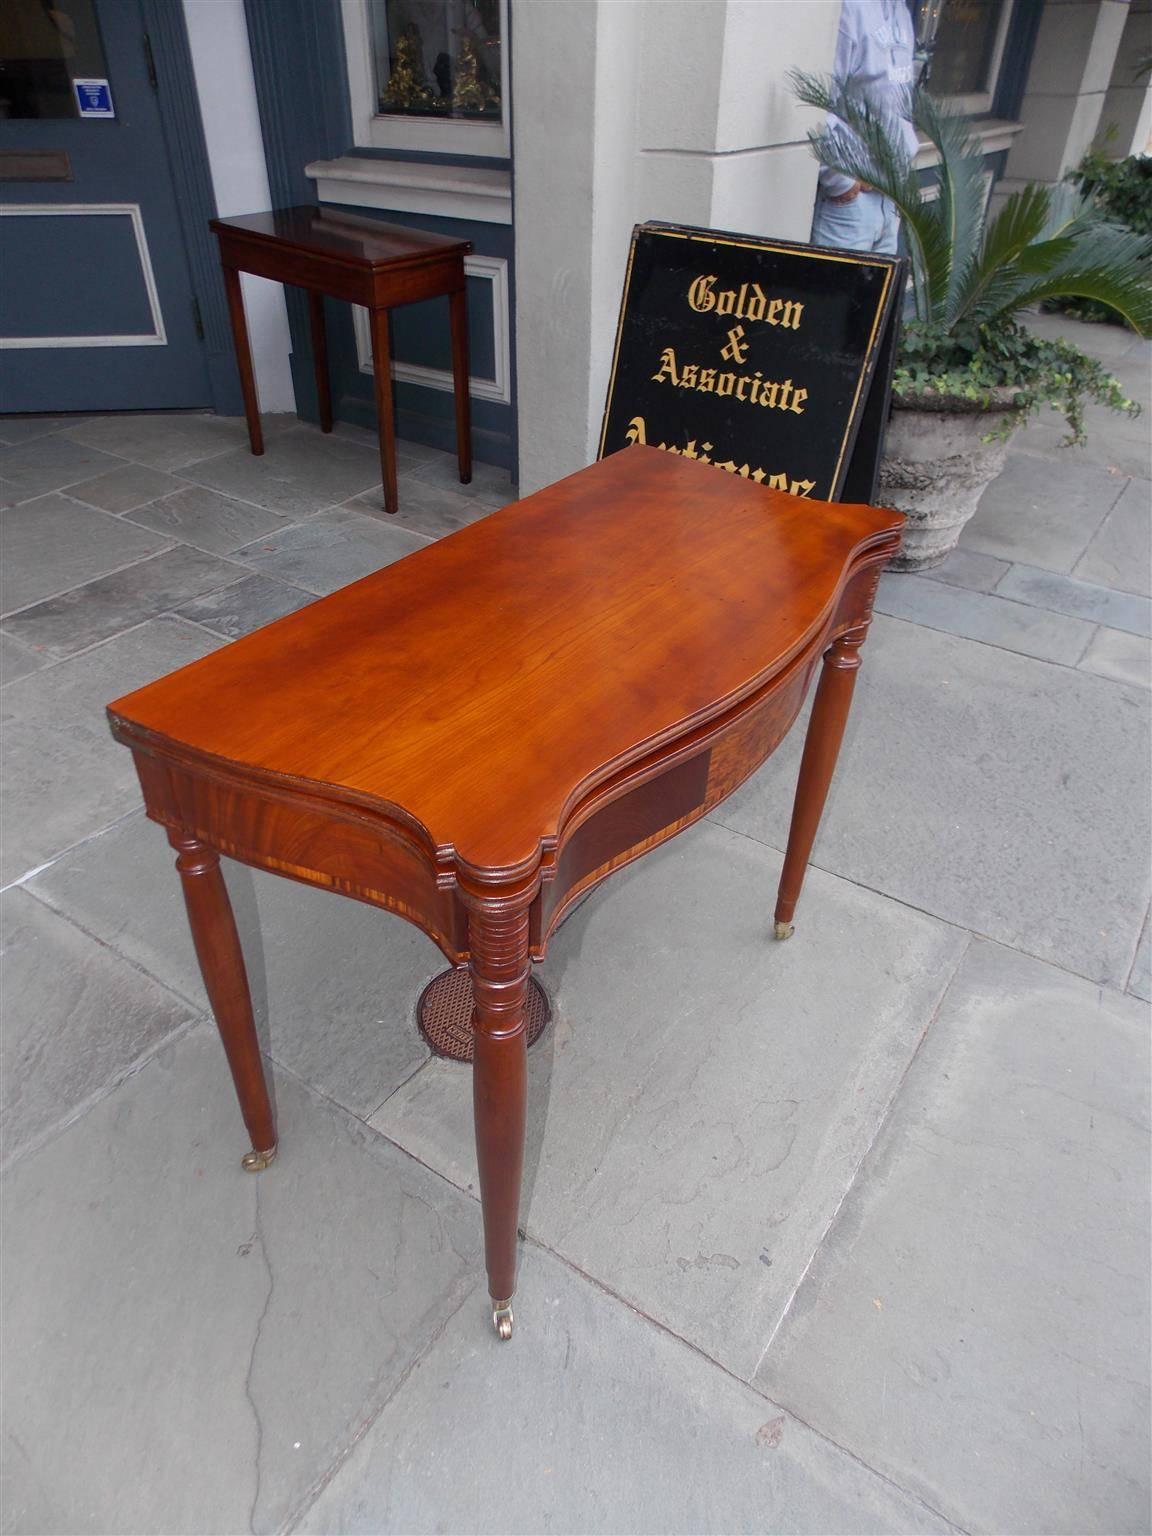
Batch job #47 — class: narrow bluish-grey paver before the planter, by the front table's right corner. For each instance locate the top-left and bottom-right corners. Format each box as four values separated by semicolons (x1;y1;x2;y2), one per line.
876;571;1092;667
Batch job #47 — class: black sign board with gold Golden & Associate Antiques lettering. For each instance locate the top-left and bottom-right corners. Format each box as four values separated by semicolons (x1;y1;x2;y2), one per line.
599;224;903;501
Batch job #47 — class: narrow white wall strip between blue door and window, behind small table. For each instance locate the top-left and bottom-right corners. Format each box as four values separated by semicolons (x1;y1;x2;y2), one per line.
183;0;296;412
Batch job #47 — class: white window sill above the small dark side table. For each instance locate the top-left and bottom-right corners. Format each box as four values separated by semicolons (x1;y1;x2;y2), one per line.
304;155;511;224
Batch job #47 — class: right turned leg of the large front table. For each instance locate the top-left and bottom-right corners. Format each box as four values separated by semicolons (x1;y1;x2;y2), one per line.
776;627;868;938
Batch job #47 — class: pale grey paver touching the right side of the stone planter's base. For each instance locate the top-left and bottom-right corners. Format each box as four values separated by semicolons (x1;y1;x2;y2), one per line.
960;452;1126;581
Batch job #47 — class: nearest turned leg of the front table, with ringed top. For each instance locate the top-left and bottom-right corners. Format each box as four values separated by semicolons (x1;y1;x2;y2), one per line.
468;906;531;1339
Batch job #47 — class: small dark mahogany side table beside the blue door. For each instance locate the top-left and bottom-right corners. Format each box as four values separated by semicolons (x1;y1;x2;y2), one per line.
209;206;472;511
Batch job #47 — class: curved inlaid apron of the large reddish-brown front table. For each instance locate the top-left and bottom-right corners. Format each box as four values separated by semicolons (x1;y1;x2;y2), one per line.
126;554;886;965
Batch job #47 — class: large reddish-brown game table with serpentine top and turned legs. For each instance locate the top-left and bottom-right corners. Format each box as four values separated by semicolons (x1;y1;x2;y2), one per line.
109;447;903;1338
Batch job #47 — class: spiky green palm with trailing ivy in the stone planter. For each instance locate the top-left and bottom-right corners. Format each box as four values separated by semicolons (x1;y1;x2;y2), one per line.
791;71;1152;441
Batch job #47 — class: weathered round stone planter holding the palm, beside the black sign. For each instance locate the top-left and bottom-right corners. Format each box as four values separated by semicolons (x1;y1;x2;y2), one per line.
876;389;1023;571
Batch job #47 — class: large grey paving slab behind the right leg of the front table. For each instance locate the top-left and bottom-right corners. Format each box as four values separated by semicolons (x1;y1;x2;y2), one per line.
714;617;1149;986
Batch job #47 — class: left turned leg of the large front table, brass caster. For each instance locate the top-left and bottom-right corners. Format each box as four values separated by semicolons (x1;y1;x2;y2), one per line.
169;833;276;1172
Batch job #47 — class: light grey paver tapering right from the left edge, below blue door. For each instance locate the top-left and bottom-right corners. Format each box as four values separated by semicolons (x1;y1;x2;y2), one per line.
0;495;170;613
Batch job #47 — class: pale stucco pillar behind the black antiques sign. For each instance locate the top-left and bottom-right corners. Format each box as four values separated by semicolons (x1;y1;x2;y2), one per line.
513;0;840;495
